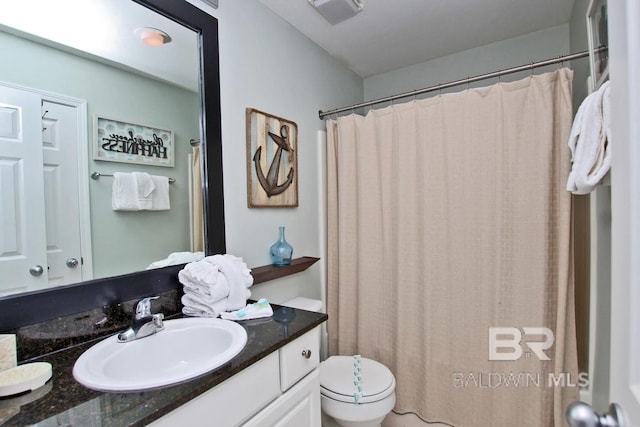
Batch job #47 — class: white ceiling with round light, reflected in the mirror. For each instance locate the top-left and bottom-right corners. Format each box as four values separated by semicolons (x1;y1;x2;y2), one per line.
0;0;200;91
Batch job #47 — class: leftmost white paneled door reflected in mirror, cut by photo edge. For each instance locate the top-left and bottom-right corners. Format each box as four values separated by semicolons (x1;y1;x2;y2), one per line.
0;86;47;295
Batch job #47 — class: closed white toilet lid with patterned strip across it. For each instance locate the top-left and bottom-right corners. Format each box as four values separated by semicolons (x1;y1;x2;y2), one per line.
320;356;396;403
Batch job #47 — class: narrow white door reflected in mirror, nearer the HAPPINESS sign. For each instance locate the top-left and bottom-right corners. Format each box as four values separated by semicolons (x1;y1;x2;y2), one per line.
42;101;82;286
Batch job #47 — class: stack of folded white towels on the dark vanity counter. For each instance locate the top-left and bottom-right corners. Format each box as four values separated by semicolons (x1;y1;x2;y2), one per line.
178;254;253;317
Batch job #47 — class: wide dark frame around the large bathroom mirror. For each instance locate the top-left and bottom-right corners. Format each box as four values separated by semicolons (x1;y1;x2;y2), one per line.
0;0;226;331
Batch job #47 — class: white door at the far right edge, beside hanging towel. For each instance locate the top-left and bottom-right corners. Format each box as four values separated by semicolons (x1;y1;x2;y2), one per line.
608;0;640;426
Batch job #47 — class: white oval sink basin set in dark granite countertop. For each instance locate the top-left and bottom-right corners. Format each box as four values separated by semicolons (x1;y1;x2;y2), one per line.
73;318;247;391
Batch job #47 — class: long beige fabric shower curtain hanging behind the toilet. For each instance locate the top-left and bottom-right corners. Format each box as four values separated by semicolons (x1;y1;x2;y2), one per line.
327;69;578;427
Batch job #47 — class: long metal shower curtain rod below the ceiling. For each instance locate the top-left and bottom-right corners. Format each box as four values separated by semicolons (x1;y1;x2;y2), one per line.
318;46;607;120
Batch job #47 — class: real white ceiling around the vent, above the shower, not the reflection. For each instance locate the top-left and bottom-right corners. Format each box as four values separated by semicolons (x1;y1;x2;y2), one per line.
258;0;574;77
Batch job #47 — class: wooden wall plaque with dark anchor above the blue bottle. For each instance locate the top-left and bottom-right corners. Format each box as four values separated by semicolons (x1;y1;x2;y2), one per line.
246;108;298;208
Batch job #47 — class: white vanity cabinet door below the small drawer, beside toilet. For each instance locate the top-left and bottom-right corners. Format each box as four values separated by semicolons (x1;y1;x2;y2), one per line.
244;369;321;427
